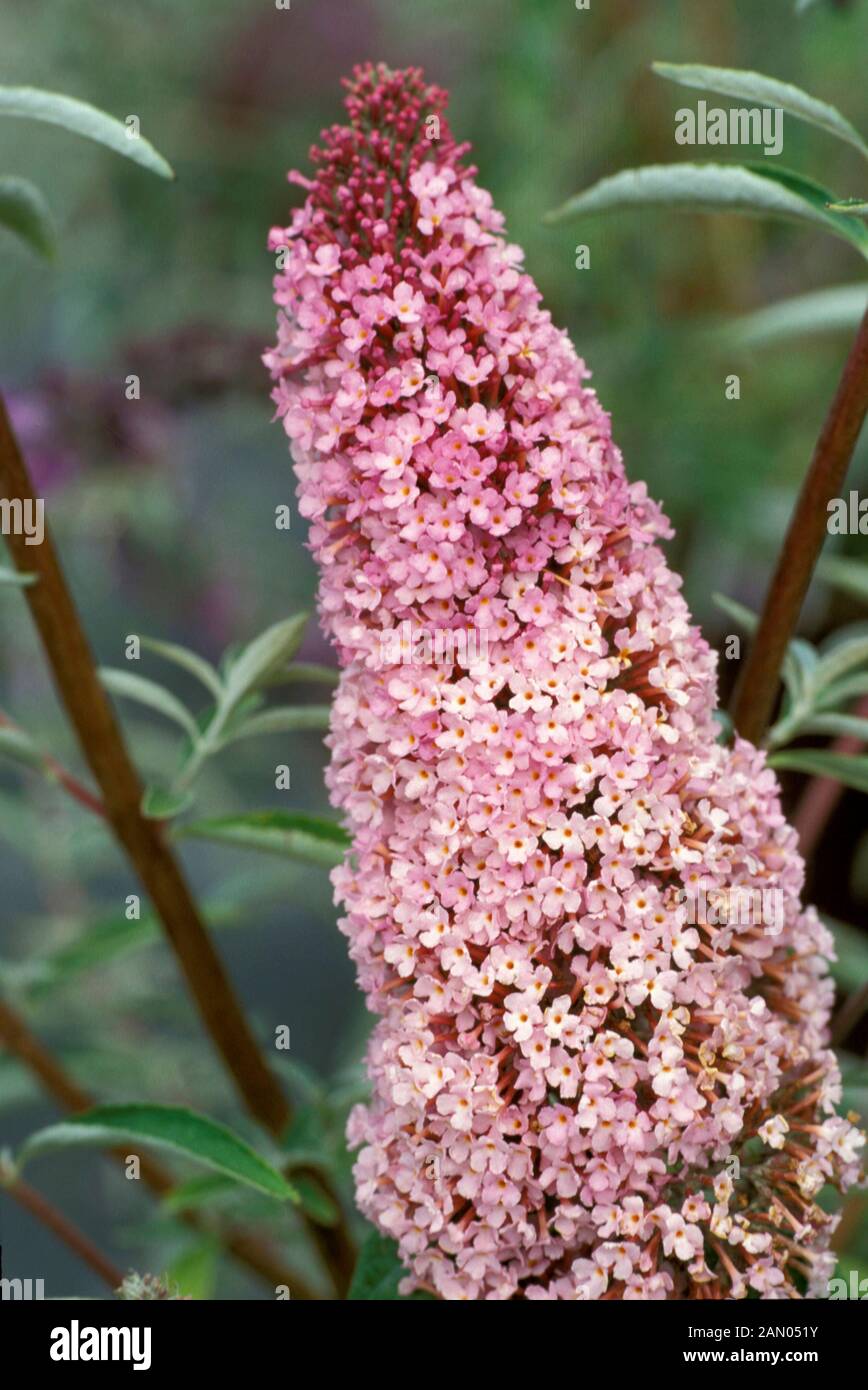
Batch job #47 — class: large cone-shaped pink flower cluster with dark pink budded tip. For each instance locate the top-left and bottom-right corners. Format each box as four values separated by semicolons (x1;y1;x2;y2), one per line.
266;67;862;1300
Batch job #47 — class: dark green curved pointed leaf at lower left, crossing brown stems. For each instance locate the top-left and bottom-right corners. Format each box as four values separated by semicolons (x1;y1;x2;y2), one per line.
18;1104;296;1201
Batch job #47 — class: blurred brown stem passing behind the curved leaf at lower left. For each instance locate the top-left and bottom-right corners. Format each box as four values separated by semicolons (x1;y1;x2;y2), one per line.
0;999;316;1301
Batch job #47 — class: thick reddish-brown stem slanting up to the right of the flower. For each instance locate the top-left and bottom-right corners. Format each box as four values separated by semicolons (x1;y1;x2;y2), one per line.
732;300;868;744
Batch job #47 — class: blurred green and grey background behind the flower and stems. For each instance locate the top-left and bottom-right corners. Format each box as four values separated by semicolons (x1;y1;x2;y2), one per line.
0;0;868;1298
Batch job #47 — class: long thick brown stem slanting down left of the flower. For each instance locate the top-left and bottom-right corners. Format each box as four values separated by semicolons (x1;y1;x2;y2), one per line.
0;395;355;1293
